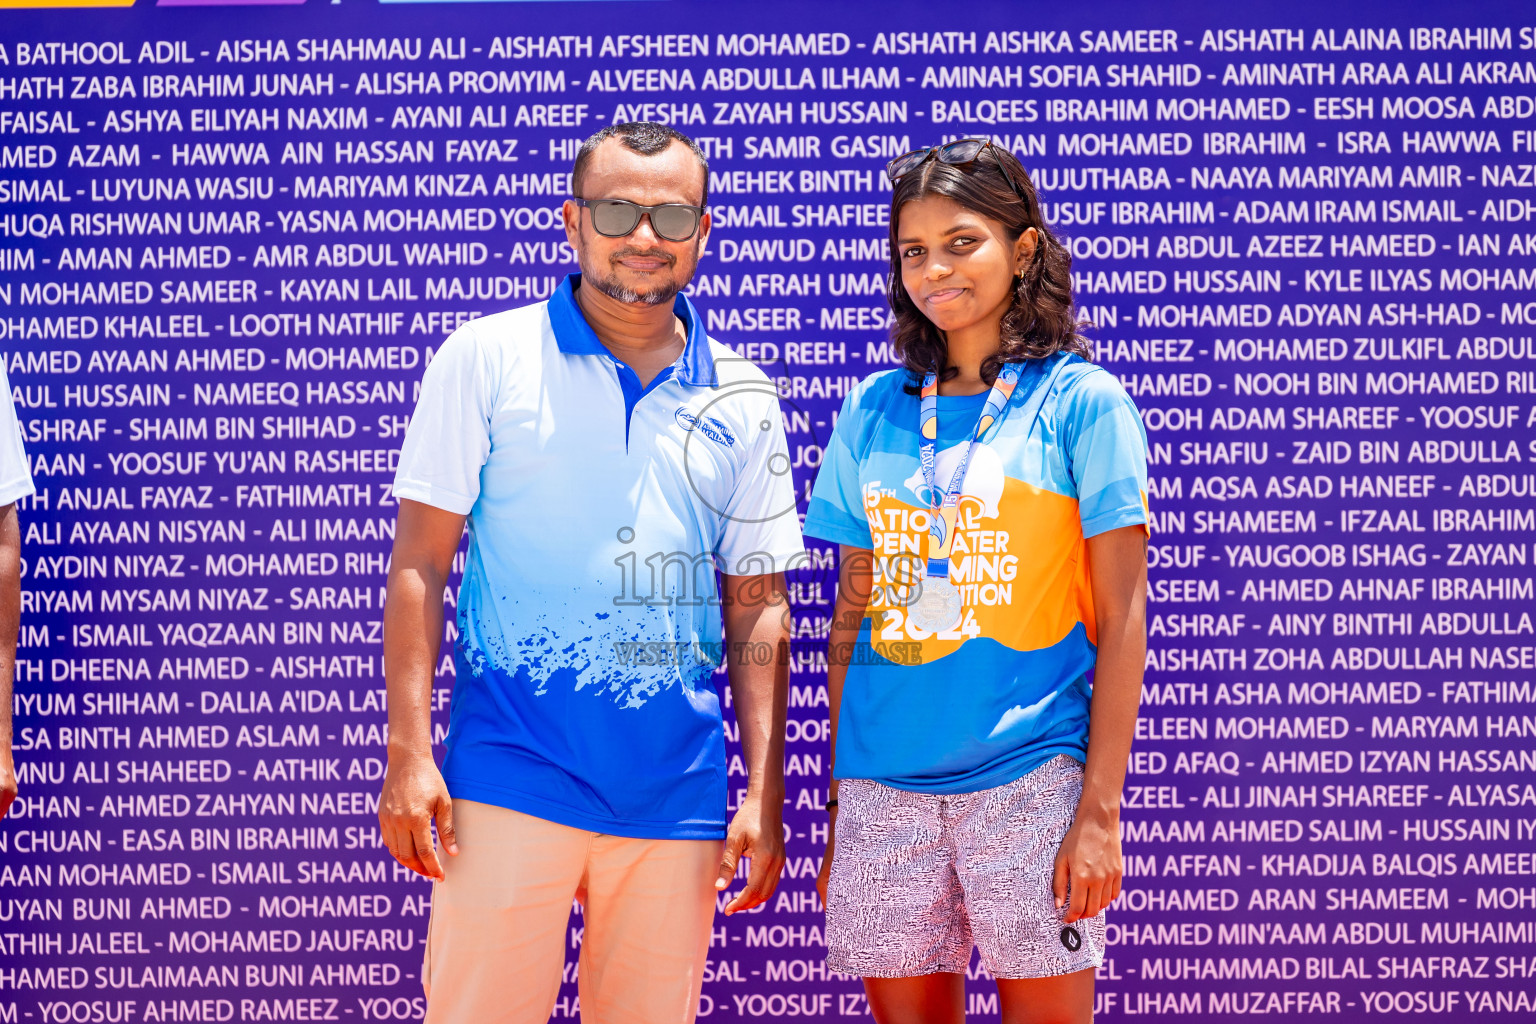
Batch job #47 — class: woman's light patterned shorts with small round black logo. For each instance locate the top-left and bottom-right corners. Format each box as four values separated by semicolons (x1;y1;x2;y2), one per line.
826;755;1104;978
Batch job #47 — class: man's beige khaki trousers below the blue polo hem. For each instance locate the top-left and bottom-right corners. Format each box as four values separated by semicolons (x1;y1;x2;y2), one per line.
421;800;722;1024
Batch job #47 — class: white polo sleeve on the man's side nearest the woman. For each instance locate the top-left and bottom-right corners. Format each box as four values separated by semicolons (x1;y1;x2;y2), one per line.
716;383;805;576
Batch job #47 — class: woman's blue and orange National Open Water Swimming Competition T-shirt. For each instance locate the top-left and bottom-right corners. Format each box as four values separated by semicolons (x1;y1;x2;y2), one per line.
805;355;1149;792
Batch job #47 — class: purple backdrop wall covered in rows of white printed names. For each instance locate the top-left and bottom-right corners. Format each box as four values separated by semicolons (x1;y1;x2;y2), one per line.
0;0;1536;1024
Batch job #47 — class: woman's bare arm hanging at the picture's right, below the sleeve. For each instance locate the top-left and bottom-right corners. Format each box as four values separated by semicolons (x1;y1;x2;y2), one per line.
1052;527;1147;921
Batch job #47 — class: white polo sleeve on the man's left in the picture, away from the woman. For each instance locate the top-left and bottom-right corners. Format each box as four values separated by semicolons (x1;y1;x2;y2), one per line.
395;327;493;516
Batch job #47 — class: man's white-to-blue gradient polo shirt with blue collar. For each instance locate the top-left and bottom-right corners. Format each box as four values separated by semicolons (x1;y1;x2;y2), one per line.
395;275;803;838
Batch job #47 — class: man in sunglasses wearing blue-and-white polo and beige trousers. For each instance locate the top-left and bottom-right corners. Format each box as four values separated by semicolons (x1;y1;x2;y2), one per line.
379;123;803;1024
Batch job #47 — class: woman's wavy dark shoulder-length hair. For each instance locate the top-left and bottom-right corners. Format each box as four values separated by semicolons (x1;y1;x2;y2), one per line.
889;146;1092;393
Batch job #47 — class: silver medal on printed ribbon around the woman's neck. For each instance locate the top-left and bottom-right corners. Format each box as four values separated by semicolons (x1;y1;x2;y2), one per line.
906;362;1023;633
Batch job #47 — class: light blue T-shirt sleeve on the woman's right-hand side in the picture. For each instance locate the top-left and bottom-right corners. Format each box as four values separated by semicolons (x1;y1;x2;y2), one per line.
1057;368;1150;539
